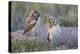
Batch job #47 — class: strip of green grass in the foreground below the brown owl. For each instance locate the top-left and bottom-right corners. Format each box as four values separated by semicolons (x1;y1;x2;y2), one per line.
12;40;55;53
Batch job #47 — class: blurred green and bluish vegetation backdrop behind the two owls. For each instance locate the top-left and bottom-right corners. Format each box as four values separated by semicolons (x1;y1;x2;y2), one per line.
11;1;78;31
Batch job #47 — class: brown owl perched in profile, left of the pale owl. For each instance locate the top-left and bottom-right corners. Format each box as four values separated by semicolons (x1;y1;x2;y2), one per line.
23;10;40;34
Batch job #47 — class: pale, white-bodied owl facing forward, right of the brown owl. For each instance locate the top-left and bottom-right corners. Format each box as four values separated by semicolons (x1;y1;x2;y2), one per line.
47;17;61;43
